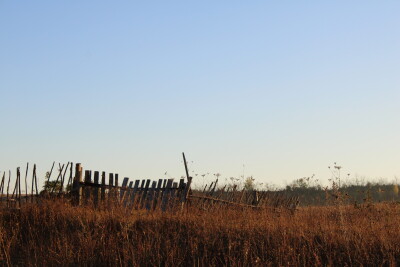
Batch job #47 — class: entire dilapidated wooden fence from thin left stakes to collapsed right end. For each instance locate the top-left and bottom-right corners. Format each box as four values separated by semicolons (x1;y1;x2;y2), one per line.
0;154;299;211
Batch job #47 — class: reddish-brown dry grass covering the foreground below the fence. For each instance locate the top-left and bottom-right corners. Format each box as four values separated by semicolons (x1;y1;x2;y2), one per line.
0;200;400;266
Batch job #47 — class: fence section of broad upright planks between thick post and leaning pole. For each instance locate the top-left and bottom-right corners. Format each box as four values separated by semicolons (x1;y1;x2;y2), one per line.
71;163;191;211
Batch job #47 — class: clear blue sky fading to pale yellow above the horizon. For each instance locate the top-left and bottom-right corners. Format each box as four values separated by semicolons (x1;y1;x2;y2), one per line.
0;0;400;192
